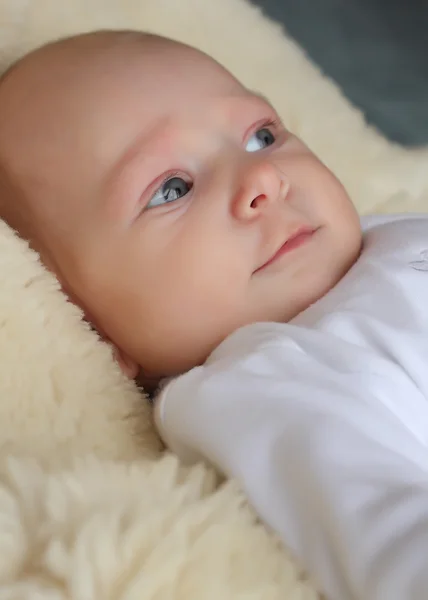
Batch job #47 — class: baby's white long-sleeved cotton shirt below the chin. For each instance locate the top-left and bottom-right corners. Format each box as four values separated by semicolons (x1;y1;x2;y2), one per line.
156;215;428;600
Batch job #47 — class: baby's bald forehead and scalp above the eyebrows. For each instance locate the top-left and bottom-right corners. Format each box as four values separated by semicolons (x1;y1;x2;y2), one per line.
0;34;251;211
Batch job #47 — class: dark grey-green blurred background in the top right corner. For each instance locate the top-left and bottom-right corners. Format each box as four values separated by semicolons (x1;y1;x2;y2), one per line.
252;0;428;145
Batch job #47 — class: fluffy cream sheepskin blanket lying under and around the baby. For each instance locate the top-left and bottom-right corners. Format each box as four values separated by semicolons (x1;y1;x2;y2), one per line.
0;0;428;600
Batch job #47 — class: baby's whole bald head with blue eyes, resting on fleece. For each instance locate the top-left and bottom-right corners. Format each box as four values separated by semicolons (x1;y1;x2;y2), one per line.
0;32;361;376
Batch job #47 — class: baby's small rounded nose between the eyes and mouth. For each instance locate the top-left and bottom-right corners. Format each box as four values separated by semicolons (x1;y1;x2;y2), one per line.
232;161;288;220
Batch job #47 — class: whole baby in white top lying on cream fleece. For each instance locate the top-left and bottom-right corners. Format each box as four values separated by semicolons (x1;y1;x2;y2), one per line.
0;32;428;600
